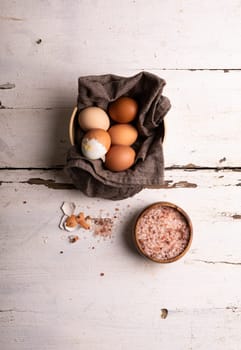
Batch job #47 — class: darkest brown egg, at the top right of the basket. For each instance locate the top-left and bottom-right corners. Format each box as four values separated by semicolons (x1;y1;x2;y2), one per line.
108;96;138;123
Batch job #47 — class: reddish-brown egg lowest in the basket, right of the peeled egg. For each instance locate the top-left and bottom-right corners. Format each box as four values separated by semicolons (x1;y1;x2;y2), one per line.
105;145;136;171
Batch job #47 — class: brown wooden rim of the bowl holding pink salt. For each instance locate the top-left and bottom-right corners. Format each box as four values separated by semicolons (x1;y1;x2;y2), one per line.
133;201;193;264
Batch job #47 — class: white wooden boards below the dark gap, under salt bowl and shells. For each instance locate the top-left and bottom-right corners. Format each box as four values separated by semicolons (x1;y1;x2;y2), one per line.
0;170;241;350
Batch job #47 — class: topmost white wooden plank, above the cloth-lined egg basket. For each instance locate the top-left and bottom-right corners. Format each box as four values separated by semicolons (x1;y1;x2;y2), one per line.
0;0;241;86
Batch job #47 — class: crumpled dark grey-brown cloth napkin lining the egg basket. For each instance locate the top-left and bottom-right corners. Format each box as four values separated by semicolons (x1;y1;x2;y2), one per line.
65;72;171;200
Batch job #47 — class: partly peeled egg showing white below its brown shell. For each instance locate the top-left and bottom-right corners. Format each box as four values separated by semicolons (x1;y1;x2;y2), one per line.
81;129;111;160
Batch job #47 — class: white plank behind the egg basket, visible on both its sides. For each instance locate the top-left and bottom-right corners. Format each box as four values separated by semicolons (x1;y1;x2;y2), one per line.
0;71;241;167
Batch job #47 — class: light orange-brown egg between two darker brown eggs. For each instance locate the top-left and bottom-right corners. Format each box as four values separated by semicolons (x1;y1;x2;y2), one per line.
108;124;138;146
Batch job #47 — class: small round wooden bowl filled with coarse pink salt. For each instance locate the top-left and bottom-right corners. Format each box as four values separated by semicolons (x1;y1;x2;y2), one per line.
134;202;193;263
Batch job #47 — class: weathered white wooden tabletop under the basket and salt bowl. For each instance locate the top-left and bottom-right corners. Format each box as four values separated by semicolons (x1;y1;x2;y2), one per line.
0;0;241;350
